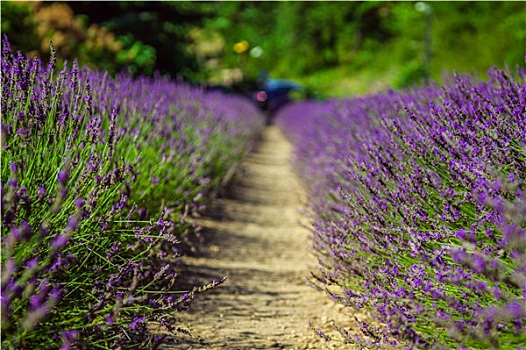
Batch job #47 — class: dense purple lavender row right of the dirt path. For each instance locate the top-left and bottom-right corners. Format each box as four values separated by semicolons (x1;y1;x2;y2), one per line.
276;69;526;349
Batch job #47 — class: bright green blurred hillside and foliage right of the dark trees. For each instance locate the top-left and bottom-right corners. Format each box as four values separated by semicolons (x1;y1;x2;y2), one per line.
203;1;526;93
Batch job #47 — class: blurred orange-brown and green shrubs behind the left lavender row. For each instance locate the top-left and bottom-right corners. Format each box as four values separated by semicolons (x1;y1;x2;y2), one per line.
2;2;156;75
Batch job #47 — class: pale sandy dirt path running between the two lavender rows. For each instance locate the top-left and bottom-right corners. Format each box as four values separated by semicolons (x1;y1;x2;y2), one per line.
170;126;358;350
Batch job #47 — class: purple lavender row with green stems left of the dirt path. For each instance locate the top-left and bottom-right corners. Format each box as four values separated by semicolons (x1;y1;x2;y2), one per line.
1;38;264;349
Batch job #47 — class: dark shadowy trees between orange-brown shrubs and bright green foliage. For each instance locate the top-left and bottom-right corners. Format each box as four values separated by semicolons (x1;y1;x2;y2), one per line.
64;1;210;81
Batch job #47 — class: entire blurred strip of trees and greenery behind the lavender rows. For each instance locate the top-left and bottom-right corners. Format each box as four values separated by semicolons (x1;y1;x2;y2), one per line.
1;1;526;96
